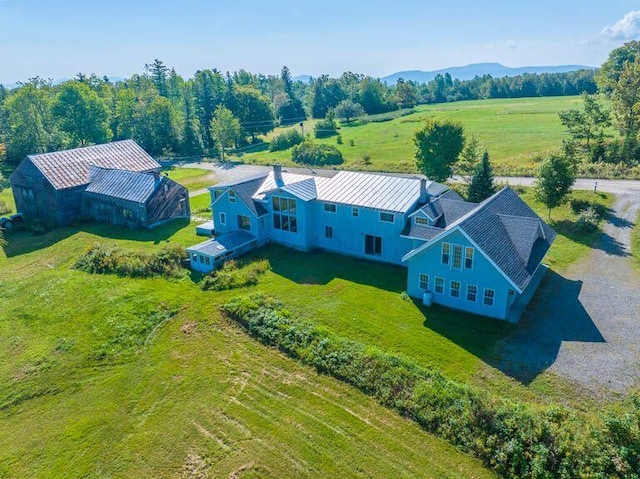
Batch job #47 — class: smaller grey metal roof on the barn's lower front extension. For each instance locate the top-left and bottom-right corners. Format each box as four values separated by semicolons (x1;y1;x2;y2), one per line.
85;166;165;203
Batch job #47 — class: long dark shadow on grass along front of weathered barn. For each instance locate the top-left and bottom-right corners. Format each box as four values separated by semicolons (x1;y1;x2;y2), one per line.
3;219;189;258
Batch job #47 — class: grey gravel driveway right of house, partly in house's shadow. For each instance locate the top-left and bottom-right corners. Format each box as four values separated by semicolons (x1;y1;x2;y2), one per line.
496;191;640;394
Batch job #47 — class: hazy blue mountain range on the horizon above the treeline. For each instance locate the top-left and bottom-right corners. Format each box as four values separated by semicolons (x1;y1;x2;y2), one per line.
293;63;596;85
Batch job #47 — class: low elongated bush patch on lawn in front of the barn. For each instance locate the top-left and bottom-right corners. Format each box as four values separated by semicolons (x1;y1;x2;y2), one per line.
74;243;187;278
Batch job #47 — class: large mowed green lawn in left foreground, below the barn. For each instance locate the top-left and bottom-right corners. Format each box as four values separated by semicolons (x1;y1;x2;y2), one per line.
0;222;493;478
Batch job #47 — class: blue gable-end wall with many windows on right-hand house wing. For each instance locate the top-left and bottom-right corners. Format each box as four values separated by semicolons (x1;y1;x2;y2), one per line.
407;231;518;319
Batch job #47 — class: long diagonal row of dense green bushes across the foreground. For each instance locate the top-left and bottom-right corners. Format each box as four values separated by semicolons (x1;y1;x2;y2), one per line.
223;294;640;479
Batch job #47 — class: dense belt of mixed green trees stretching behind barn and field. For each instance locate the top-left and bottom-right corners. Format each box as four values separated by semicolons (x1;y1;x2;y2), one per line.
0;60;596;166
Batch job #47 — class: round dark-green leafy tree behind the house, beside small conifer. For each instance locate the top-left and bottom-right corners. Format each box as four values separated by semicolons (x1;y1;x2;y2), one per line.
414;119;464;181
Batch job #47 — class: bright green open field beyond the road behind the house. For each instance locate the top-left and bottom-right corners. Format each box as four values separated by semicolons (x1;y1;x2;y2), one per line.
240;96;581;175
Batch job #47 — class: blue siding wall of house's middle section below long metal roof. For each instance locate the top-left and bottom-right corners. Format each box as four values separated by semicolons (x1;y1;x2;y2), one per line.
312;201;413;265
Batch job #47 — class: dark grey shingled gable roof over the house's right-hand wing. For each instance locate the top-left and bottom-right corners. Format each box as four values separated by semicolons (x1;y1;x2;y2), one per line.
403;187;556;291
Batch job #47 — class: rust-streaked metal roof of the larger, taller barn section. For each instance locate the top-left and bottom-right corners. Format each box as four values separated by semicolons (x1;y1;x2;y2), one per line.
27;140;160;190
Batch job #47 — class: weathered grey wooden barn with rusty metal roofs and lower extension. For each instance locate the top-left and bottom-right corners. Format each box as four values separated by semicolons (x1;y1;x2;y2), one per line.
11;140;191;228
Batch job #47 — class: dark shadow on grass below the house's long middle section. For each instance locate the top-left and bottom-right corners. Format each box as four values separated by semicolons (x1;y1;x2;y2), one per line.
264;245;407;299
